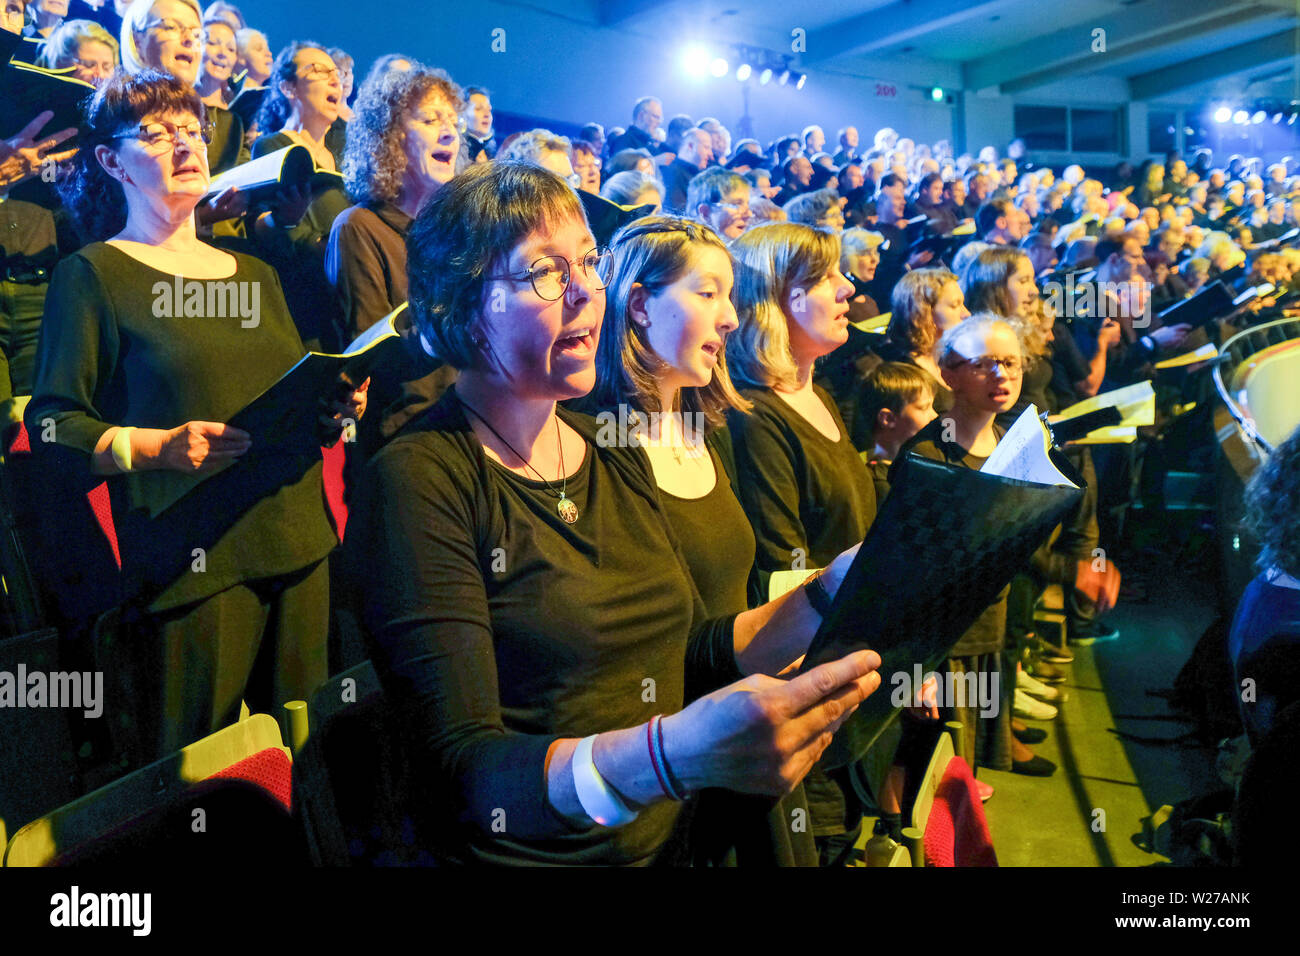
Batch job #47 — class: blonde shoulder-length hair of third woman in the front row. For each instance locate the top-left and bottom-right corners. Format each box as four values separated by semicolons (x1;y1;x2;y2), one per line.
727;222;840;389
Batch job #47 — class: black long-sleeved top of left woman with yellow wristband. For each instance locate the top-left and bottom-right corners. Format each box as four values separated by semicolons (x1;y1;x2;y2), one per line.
26;242;338;611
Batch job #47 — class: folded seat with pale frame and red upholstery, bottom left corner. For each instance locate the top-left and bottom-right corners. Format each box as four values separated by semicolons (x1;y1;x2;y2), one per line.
4;714;297;866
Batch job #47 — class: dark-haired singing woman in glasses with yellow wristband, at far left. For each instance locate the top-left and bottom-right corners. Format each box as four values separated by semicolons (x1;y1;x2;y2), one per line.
27;70;365;762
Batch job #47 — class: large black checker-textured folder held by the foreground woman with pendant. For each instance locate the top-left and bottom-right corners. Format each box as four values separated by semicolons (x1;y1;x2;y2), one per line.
803;453;1083;769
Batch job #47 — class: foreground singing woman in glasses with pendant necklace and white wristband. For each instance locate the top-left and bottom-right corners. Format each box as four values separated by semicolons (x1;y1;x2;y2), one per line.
346;163;879;865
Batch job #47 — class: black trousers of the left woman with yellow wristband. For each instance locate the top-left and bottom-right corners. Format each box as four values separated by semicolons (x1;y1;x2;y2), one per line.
96;561;329;766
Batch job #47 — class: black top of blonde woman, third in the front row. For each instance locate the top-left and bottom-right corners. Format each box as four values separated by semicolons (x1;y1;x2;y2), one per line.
728;386;876;836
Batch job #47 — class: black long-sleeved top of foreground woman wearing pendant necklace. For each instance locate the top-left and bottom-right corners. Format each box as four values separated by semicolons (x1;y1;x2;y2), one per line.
345;389;741;864
